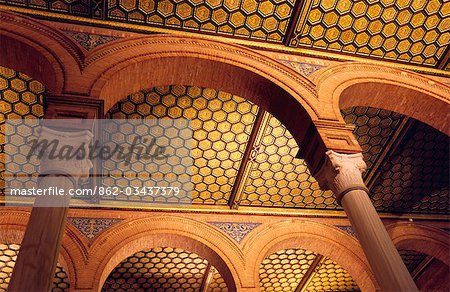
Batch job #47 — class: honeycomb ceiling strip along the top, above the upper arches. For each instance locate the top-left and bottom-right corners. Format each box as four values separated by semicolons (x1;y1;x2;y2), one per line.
0;0;450;70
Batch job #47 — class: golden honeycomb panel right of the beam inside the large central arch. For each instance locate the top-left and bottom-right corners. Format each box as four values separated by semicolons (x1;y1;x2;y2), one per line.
240;113;338;209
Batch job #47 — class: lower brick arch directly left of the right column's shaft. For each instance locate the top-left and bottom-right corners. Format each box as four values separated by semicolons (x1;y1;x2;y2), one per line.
243;220;378;291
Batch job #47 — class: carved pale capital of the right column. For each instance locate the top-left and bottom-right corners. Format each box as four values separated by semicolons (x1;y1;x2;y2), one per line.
315;150;369;204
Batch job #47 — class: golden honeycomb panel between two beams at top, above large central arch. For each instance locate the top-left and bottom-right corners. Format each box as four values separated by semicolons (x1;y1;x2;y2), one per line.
107;0;295;42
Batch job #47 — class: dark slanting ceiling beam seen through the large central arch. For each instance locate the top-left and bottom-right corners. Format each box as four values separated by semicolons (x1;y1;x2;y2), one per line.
228;108;266;209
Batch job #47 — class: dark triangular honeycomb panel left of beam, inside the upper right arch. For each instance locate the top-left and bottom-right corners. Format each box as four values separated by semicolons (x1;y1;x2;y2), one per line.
342;106;404;175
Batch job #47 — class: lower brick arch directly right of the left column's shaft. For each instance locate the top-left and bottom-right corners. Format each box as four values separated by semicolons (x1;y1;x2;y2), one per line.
85;216;244;291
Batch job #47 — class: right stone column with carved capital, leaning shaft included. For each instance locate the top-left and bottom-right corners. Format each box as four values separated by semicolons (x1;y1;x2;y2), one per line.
316;151;418;291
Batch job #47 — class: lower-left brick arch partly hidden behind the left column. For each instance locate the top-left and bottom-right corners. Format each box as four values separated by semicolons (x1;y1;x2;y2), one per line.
0;210;86;291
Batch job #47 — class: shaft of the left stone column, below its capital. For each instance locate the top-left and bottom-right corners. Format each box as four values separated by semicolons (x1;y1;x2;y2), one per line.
8;176;74;291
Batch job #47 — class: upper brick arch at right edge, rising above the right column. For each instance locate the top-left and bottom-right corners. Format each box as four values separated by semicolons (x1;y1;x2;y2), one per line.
312;63;450;135
